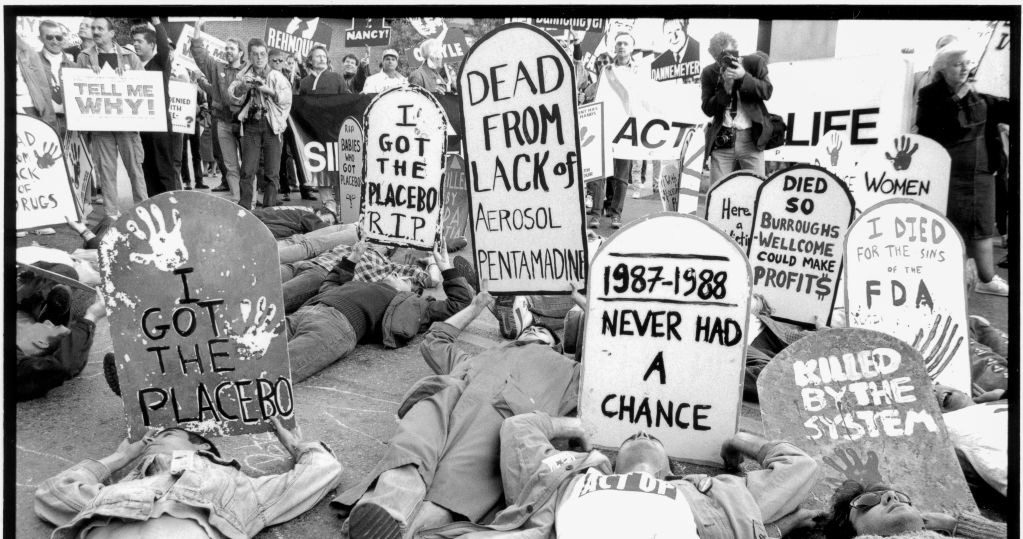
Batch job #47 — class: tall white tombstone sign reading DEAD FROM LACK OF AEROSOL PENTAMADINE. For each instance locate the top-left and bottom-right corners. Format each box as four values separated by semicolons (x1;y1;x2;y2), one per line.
458;23;586;295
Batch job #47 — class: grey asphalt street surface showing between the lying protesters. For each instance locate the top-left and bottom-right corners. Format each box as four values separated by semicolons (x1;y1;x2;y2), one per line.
15;175;1008;538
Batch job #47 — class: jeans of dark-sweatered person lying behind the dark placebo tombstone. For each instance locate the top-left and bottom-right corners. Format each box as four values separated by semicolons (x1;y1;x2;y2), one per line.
287;305;356;384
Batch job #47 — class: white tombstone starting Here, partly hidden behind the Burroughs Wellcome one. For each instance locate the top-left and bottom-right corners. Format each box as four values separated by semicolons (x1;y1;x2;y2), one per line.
704;171;763;250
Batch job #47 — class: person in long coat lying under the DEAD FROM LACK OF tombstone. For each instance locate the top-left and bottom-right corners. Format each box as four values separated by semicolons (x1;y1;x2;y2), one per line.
331;291;579;539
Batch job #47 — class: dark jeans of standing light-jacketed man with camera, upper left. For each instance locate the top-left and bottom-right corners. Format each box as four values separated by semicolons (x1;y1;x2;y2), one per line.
238;117;282;210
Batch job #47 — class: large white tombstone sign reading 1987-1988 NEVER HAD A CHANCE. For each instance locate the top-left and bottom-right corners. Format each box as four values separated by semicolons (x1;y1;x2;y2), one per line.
579;213;751;464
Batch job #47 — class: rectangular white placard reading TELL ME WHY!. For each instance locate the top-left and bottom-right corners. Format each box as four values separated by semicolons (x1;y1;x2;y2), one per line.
61;64;167;131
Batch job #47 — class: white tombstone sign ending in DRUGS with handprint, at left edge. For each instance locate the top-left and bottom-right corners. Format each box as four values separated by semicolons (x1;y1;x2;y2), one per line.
13;115;85;230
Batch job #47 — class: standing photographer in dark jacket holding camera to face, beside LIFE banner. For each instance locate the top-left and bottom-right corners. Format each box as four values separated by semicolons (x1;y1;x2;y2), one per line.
700;32;773;184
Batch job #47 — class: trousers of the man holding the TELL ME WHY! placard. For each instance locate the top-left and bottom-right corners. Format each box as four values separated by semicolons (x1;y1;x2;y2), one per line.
89;131;149;219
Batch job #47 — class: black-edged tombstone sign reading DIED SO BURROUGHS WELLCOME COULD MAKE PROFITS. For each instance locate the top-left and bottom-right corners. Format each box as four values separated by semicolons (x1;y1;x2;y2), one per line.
749;165;853;324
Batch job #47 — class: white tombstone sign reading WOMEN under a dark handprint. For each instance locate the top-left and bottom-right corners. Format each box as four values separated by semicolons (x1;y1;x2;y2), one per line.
848;134;951;215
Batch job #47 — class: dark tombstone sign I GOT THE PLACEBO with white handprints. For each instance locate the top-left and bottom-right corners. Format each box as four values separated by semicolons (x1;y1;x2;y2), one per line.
99;191;295;440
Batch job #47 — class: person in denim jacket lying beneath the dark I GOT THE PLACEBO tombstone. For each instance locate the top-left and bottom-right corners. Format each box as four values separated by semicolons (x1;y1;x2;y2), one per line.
35;417;342;539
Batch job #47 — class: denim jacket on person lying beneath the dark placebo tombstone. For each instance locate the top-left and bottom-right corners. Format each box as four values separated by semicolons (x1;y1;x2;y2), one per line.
35;442;342;539
